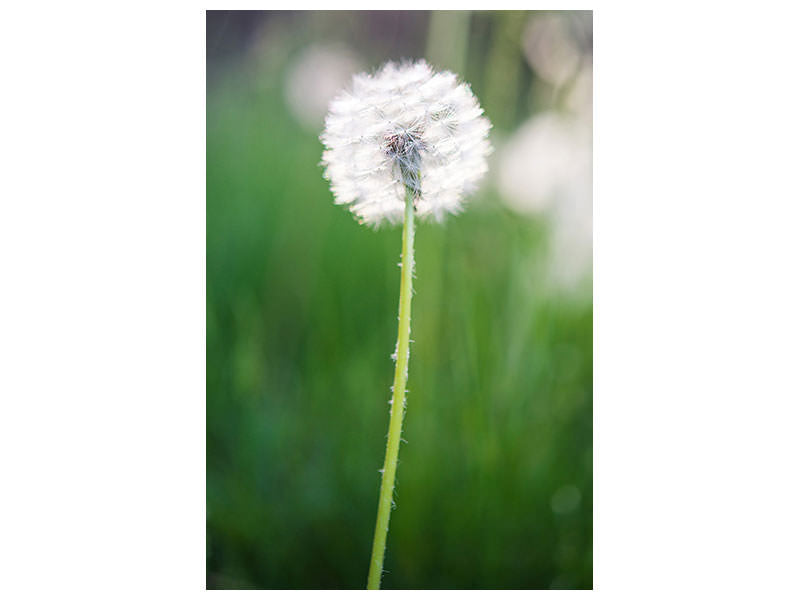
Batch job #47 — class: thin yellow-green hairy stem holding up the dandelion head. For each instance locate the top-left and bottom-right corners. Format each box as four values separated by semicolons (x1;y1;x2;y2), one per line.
367;189;414;590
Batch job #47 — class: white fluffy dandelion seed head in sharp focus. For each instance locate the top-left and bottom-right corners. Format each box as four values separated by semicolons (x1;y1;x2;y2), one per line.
320;60;492;225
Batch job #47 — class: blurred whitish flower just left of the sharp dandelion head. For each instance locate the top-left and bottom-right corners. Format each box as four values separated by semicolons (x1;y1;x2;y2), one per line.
284;44;362;131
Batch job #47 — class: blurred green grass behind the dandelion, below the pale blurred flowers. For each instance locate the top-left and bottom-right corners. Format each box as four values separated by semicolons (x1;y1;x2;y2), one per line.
207;63;592;589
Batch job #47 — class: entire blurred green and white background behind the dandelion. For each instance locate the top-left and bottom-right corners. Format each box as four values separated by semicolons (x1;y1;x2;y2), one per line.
206;11;592;589
